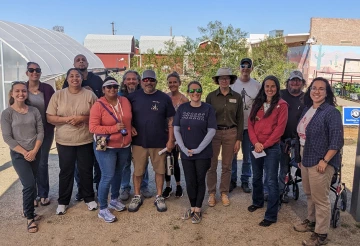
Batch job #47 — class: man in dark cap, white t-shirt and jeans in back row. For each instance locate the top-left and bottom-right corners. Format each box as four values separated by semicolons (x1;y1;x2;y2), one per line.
229;58;261;193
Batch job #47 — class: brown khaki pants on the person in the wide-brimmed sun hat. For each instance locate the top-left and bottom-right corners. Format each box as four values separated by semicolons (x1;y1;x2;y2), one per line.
207;127;237;194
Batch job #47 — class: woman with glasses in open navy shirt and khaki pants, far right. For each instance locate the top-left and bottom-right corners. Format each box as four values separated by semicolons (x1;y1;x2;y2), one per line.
294;77;344;245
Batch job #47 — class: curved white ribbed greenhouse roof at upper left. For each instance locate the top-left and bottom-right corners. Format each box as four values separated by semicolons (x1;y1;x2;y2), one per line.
0;21;104;76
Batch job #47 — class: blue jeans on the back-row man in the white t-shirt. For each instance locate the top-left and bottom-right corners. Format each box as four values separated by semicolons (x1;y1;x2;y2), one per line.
231;130;251;183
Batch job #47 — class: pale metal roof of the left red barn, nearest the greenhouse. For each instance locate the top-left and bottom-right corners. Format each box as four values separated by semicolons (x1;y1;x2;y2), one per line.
84;34;135;54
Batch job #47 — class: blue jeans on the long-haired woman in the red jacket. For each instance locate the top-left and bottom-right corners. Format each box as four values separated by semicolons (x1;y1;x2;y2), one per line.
251;143;280;222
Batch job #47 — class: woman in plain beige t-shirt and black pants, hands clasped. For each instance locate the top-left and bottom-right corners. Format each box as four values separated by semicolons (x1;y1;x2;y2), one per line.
46;68;97;215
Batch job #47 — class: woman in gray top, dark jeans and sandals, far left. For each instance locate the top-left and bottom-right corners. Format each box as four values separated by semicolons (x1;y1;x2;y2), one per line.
1;81;44;233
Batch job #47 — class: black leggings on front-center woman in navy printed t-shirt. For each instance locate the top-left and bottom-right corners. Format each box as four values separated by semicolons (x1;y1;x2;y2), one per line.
181;159;211;208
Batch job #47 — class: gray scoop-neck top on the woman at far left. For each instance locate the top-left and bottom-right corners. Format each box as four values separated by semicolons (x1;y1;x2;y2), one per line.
1;106;44;151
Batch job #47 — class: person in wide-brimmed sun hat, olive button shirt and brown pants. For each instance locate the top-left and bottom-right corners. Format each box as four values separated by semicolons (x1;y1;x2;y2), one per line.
206;68;244;207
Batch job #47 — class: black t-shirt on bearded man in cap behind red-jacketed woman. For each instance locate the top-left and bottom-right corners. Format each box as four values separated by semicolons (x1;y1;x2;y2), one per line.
280;89;304;140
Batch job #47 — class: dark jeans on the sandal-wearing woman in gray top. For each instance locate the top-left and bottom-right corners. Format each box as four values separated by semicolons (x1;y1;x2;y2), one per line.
10;149;41;219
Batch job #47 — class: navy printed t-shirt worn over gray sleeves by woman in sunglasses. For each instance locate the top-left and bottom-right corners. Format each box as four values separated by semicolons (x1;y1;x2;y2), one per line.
173;102;217;160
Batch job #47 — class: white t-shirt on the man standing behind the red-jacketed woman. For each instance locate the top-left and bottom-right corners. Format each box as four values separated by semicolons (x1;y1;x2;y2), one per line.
231;78;261;130
